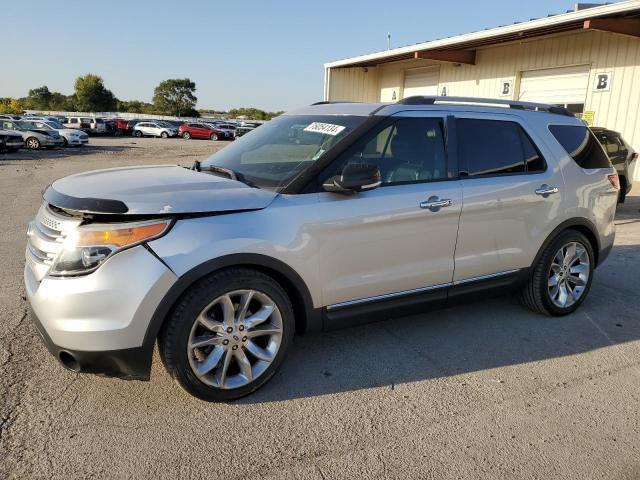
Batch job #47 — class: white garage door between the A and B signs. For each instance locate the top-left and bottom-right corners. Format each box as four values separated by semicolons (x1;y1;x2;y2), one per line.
520;65;589;113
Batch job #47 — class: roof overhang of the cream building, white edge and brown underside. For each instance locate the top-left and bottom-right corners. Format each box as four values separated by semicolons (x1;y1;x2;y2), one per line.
324;0;640;68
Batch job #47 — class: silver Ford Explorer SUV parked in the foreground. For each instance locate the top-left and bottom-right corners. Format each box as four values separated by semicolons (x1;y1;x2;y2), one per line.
24;97;619;401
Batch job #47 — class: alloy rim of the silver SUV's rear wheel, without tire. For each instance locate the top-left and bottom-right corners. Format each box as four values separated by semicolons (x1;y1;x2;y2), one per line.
548;242;591;308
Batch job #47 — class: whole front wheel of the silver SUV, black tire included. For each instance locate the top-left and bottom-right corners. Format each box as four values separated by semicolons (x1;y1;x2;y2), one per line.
158;268;294;402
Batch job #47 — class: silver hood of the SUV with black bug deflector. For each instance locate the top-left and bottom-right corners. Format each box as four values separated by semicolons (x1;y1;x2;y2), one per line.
44;165;277;215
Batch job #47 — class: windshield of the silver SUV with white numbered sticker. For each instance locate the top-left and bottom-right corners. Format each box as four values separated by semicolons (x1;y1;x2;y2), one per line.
202;115;367;191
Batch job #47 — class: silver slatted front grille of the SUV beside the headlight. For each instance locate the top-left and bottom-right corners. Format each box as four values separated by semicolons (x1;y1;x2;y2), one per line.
25;203;82;281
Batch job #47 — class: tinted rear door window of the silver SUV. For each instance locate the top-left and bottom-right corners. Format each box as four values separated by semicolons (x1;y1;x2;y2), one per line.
456;118;546;177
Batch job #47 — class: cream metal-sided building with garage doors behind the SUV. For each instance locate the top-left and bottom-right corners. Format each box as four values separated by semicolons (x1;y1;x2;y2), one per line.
325;0;640;178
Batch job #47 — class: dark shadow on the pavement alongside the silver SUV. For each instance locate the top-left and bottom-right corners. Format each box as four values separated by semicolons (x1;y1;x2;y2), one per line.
238;197;640;404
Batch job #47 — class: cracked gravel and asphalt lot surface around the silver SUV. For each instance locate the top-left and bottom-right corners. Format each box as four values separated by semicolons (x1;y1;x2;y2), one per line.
0;138;640;480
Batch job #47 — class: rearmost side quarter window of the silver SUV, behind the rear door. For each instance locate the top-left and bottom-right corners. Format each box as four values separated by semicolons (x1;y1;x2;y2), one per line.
549;125;611;168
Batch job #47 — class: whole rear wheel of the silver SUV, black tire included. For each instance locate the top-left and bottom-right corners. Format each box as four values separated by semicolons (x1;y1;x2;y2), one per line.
520;230;595;316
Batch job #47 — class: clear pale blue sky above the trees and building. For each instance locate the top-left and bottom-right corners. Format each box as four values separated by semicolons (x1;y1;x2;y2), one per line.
0;0;608;111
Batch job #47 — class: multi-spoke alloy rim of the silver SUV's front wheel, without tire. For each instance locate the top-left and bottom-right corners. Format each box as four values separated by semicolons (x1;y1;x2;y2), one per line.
187;290;283;389
